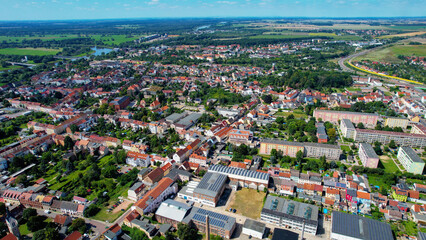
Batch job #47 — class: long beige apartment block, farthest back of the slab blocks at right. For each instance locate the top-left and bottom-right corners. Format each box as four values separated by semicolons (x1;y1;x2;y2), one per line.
314;109;379;127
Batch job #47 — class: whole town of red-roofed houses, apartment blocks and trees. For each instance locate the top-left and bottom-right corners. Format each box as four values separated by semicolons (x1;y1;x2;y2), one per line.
0;17;426;240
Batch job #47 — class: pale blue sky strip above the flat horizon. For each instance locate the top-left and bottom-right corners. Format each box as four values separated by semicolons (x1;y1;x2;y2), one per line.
0;0;426;20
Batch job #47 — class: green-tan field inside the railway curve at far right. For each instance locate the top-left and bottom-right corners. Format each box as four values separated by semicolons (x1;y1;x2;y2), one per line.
354;44;426;62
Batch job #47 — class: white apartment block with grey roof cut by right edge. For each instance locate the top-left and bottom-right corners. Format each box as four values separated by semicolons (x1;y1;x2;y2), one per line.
397;147;425;174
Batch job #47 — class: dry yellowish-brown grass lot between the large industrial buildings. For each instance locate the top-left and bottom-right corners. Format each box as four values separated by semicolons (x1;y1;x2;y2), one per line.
231;188;266;219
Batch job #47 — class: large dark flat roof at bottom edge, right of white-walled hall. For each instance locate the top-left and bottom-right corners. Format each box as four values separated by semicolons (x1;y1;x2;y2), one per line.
331;211;394;240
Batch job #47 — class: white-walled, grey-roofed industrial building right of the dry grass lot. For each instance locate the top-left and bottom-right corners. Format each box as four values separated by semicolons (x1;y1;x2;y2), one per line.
260;196;319;235
